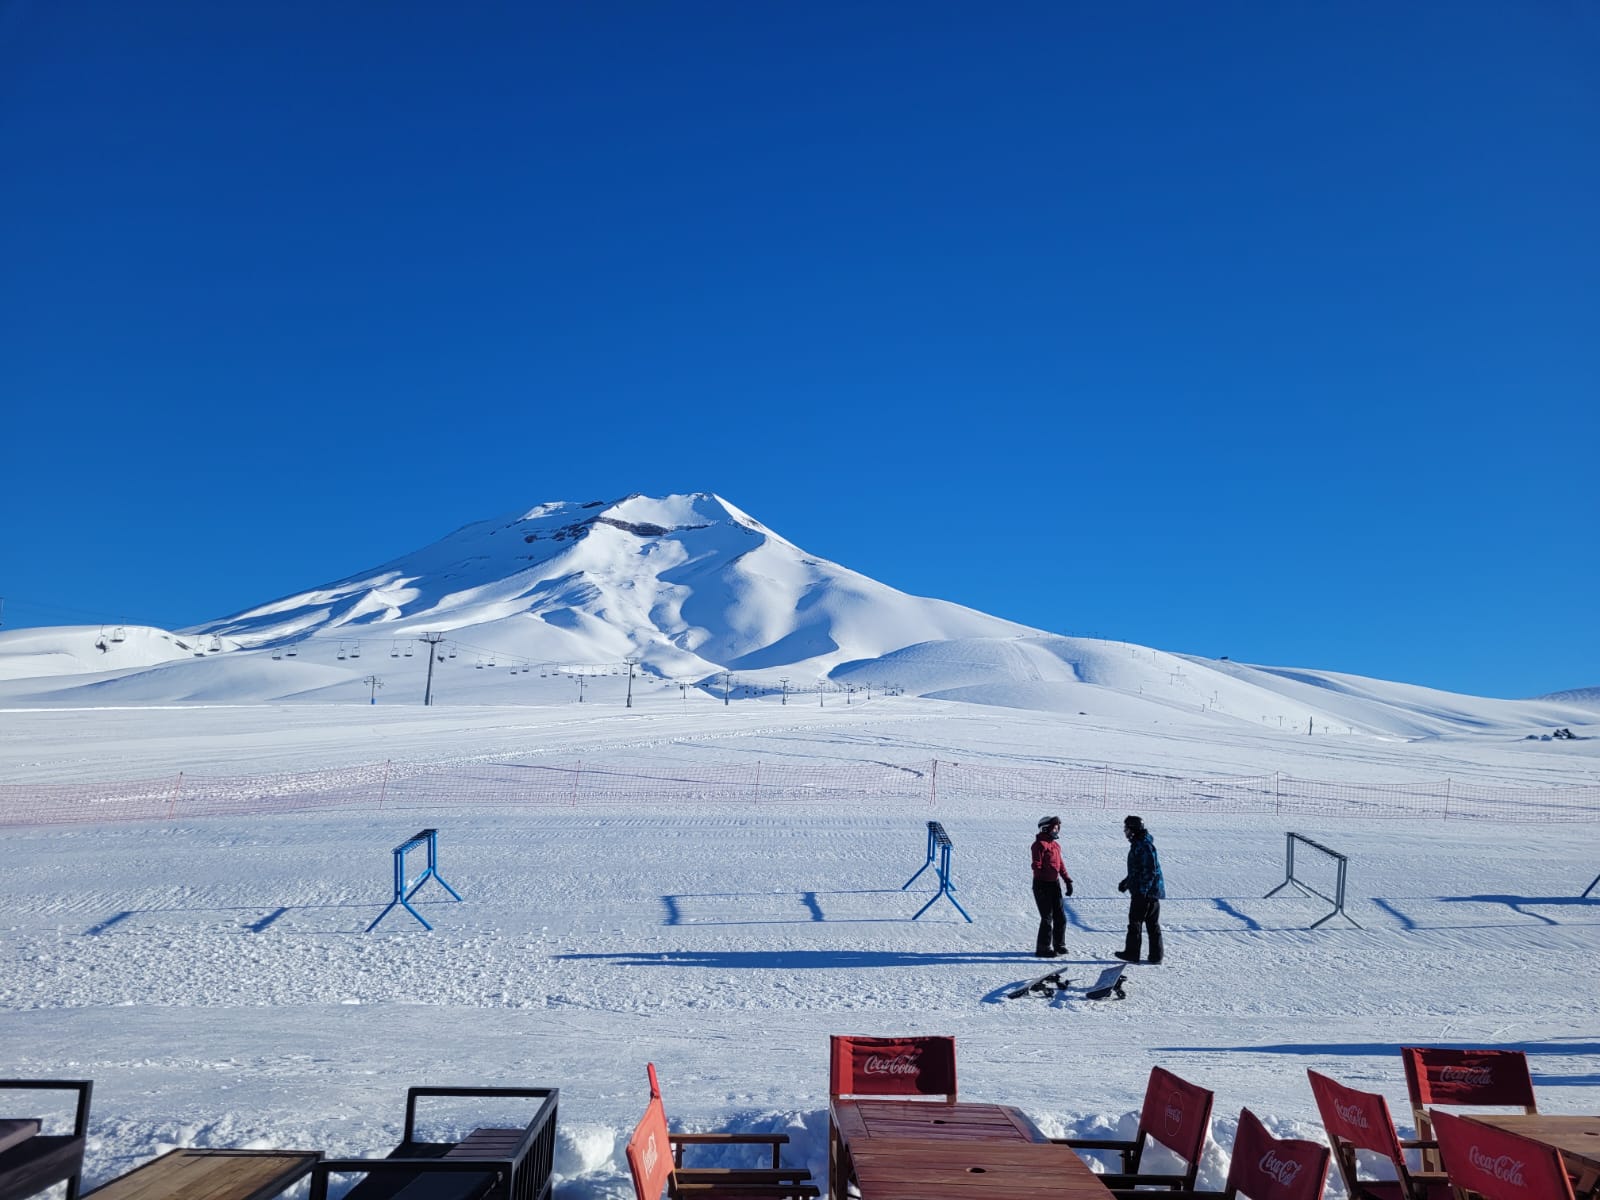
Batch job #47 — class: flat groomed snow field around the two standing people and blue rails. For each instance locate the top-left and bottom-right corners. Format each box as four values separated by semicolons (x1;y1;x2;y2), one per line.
0;694;1600;1198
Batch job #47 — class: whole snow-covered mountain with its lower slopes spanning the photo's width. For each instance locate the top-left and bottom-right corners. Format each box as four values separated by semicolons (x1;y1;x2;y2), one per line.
0;493;1595;739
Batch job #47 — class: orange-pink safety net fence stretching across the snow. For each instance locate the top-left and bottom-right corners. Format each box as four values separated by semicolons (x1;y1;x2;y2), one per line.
0;758;1600;826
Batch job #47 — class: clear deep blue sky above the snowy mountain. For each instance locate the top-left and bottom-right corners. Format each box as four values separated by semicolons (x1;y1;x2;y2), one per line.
0;0;1600;696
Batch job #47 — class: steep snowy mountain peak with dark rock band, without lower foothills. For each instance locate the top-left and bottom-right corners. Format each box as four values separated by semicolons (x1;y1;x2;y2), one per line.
192;493;1035;678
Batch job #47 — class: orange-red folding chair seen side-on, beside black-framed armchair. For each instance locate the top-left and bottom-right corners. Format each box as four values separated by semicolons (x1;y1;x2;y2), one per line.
626;1062;819;1200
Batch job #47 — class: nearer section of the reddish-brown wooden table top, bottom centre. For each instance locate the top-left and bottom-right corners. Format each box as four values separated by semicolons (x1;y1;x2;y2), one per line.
850;1138;1110;1200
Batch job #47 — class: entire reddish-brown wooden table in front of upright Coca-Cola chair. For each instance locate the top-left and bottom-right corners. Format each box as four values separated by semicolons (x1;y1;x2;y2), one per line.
829;1101;1107;1200
